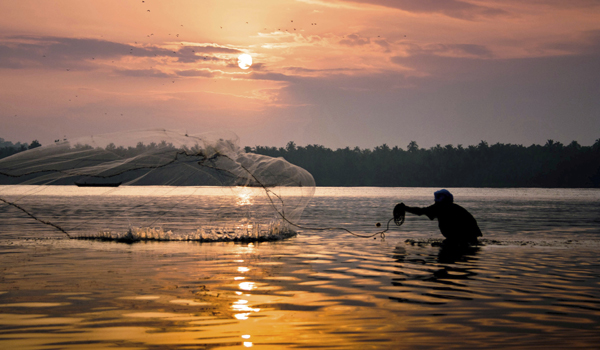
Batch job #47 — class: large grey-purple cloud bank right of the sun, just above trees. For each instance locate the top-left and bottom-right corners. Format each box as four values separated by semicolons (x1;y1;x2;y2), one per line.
253;45;600;147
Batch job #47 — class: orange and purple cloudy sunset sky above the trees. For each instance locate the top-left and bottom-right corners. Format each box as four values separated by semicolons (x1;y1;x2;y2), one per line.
0;0;600;149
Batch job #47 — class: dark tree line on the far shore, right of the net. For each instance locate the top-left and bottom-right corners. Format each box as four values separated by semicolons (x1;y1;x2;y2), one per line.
245;139;600;188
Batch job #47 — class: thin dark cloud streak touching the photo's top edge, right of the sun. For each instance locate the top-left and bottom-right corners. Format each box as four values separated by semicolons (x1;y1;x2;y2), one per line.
343;0;507;19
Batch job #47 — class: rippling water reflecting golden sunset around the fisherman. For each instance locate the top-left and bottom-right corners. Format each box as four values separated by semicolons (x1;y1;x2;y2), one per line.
0;188;600;349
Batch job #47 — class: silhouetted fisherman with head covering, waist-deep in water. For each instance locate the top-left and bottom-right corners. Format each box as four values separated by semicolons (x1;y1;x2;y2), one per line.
394;190;482;245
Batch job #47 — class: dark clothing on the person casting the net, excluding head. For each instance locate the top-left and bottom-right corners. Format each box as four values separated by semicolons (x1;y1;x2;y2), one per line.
404;203;482;243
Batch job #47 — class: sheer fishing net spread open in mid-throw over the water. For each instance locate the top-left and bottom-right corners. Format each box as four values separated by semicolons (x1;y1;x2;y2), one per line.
0;130;315;241
